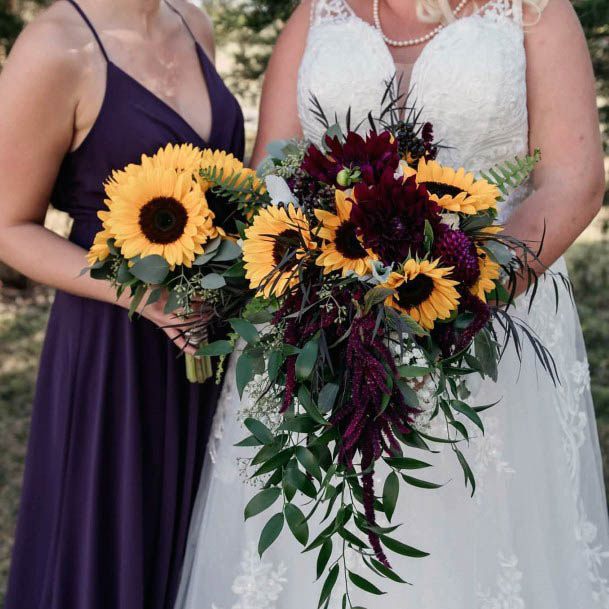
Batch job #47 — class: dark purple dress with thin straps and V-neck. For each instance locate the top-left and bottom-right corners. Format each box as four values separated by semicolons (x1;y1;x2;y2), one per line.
6;0;244;609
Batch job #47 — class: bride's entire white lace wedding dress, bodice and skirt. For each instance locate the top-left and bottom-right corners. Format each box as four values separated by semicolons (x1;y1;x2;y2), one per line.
177;0;609;609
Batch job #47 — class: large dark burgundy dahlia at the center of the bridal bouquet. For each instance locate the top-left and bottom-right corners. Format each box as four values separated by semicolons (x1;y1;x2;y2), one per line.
351;170;440;264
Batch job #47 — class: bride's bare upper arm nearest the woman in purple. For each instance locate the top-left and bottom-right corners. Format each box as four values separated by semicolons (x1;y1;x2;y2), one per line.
251;0;311;167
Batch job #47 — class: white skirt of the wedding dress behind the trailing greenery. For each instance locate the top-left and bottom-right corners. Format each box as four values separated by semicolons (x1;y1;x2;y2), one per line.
176;261;609;609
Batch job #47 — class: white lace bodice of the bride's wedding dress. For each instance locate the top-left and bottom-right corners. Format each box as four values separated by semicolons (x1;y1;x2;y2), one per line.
298;0;528;183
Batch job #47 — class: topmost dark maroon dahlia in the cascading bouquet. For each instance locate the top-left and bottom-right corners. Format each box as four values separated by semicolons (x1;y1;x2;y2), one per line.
302;131;400;188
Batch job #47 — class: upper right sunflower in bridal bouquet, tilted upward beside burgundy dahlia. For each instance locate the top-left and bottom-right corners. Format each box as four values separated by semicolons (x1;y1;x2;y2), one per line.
417;159;501;214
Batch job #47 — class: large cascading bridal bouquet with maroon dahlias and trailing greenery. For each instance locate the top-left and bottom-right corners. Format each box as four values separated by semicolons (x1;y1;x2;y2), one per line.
201;100;566;608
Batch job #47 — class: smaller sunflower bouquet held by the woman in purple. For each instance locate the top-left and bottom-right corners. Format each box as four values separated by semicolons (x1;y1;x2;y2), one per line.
87;145;262;382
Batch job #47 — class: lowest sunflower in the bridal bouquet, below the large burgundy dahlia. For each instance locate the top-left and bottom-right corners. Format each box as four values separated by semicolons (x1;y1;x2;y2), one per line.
383;258;459;330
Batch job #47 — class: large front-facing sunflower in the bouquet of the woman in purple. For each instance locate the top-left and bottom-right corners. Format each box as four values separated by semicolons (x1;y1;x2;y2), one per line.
98;166;217;267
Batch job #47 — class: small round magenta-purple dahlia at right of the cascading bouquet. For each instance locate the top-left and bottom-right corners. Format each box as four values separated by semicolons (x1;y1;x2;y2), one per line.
433;224;480;287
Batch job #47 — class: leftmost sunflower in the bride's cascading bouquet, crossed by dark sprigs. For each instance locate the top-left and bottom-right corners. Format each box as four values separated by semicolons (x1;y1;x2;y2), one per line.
243;204;316;298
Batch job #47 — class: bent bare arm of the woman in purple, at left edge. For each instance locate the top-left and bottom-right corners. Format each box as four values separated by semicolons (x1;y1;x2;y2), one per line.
0;13;195;346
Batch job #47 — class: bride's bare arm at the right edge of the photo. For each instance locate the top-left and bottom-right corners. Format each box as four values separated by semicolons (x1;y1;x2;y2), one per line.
506;0;605;278
